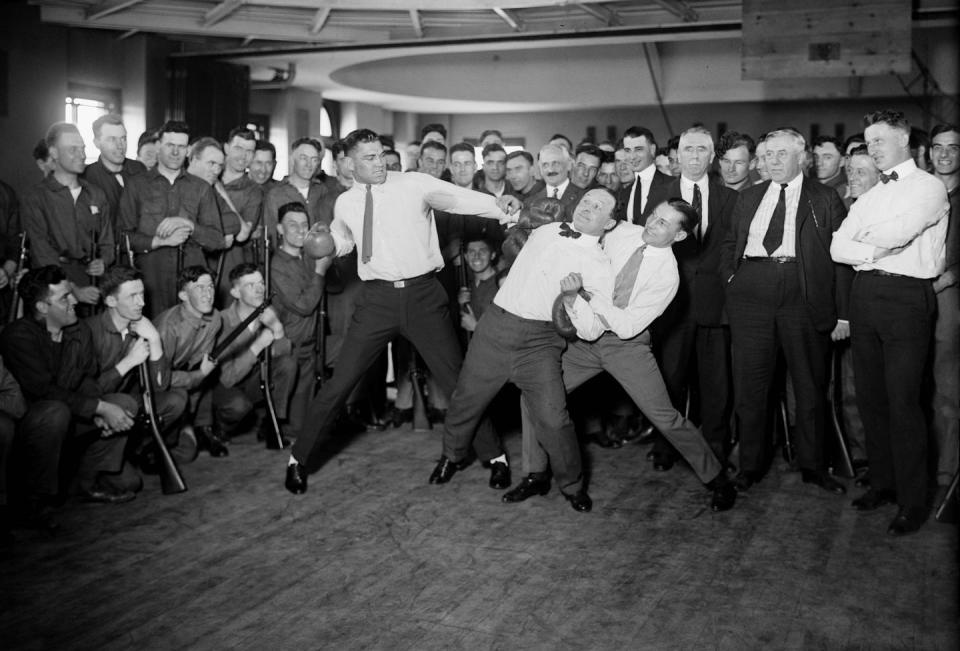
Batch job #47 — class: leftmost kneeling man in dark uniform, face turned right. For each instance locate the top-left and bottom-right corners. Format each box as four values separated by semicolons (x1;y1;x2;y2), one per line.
0;265;142;505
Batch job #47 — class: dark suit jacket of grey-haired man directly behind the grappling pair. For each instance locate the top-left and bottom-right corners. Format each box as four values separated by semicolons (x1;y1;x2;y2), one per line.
664;178;738;326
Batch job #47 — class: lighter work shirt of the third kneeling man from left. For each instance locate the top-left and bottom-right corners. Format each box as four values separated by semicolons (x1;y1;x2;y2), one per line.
154;303;223;390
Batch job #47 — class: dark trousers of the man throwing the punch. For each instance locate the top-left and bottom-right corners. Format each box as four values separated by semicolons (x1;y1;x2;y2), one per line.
293;276;500;472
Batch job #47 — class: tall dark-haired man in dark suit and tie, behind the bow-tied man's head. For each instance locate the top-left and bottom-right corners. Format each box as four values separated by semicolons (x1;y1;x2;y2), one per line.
617;127;673;226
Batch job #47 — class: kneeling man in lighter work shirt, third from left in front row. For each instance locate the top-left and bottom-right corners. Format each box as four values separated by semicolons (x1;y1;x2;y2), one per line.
156;265;230;457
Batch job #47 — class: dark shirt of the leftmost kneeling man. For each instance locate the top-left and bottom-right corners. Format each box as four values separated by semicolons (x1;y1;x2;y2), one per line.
0;317;103;419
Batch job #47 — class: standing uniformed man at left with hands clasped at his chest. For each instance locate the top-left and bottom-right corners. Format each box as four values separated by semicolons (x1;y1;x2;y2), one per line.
120;121;226;316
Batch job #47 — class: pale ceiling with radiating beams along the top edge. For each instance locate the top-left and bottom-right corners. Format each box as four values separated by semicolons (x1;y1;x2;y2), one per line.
30;0;741;50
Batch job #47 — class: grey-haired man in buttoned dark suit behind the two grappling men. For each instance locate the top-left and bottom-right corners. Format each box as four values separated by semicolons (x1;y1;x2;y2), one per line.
653;127;737;471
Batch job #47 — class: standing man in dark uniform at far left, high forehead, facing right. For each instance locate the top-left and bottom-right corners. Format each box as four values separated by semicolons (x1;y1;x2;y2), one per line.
21;122;114;305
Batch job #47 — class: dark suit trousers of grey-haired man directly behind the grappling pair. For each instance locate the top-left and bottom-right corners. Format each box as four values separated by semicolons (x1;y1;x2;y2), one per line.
654;319;731;458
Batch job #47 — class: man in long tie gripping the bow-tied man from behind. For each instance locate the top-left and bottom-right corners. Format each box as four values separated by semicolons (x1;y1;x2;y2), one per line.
503;199;736;511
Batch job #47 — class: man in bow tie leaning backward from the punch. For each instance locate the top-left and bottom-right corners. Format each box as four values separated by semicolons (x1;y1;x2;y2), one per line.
430;188;616;511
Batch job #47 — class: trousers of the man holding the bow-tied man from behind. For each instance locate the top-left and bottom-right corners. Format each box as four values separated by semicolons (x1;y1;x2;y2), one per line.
523;332;723;483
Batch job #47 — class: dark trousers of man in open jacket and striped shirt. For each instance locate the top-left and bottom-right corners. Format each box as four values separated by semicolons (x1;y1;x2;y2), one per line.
727;260;830;473
